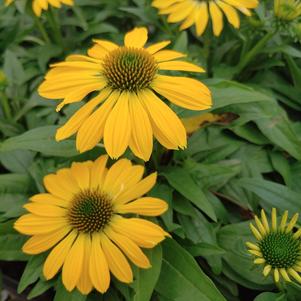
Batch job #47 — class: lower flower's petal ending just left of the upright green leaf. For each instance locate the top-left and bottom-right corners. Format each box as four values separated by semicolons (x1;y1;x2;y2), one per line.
100;235;133;283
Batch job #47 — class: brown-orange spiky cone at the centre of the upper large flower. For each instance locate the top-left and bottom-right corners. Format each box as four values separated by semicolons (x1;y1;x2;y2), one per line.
103;47;157;92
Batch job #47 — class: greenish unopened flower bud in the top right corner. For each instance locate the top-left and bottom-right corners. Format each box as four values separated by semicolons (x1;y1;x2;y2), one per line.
274;0;301;21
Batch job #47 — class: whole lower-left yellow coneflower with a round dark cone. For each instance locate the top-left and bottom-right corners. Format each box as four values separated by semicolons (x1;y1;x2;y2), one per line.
14;155;168;294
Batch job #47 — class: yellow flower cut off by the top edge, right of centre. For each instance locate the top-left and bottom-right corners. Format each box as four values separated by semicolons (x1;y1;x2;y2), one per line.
152;0;259;36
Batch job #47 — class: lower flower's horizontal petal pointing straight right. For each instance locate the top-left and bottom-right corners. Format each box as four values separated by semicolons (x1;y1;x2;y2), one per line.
116;197;168;216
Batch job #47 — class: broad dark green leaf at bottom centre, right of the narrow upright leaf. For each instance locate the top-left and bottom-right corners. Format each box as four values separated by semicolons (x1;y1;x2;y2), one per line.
156;239;226;301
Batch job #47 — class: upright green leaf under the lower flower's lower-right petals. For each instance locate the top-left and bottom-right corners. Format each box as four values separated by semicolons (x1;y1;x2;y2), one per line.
133;245;162;301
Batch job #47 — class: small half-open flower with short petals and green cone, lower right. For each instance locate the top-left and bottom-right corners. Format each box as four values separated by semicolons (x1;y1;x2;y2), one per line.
247;208;301;283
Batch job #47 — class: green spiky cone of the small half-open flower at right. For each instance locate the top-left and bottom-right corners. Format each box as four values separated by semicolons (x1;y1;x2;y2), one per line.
259;232;301;269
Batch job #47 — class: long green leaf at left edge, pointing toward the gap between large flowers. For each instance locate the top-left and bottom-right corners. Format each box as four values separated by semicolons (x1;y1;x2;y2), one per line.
0;126;78;157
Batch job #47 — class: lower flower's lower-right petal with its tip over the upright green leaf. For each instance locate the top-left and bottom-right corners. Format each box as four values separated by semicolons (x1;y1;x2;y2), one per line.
105;229;151;269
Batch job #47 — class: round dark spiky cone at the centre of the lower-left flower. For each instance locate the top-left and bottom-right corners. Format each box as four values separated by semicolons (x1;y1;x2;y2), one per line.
68;190;113;233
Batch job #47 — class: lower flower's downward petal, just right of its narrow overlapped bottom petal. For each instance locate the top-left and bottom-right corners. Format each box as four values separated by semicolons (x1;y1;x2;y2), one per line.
89;233;110;293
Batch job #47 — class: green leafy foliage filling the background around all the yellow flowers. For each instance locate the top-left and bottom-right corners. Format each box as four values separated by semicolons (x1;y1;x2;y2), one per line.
0;0;301;301
